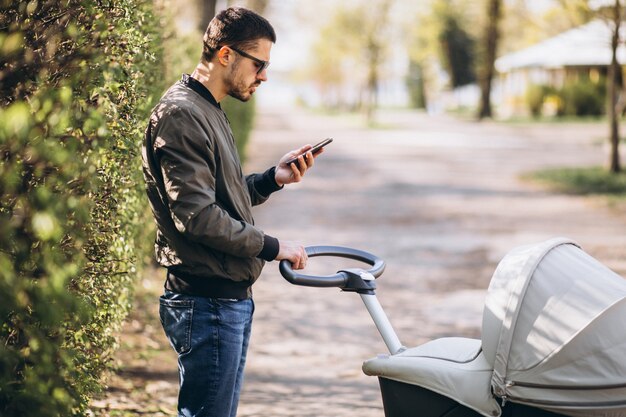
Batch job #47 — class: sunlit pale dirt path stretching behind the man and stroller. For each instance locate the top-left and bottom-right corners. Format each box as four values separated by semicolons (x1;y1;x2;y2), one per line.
90;110;626;417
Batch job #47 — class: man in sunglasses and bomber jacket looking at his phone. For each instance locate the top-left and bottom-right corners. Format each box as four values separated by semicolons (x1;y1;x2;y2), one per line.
142;7;314;417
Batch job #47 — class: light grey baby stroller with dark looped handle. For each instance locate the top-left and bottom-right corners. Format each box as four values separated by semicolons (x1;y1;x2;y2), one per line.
280;238;626;417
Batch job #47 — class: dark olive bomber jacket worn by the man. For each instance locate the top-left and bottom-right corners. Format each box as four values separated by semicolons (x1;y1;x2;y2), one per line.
142;75;280;295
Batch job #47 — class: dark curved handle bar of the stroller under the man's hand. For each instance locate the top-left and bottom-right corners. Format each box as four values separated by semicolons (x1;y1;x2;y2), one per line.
279;246;385;288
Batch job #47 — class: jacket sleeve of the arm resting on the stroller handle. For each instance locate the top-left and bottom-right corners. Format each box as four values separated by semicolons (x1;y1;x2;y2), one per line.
154;105;264;257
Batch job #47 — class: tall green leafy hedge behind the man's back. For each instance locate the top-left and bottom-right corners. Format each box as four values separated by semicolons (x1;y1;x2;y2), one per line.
0;0;163;417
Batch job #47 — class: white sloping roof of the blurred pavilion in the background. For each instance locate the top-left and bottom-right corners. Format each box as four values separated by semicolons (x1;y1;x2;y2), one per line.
496;20;626;73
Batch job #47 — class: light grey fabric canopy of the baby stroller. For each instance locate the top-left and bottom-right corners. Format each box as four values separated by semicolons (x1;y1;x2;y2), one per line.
482;238;626;417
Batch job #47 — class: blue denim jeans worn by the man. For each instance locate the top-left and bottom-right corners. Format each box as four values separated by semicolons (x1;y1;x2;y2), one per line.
159;290;254;417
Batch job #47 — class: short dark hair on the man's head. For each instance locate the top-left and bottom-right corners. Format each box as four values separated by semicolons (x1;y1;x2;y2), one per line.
202;7;276;61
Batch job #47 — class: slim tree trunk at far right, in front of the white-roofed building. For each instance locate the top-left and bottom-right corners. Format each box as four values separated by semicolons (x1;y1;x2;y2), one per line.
608;0;622;173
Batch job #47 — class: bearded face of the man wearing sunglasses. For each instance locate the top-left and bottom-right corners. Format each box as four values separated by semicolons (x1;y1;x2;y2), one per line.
226;39;272;101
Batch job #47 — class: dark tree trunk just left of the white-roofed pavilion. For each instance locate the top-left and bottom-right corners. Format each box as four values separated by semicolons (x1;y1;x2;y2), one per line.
478;0;502;119
